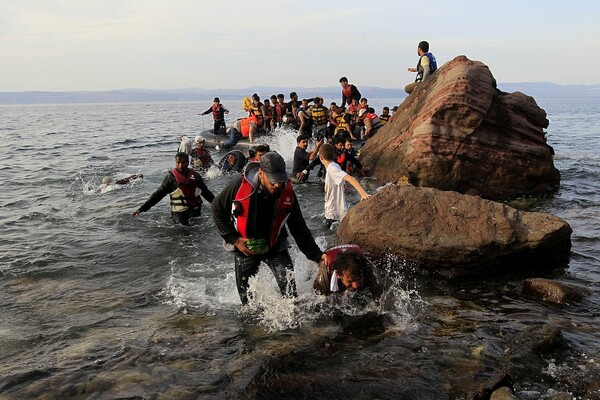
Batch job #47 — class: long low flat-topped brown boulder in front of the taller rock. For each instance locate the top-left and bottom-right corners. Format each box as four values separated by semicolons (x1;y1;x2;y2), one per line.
338;185;572;277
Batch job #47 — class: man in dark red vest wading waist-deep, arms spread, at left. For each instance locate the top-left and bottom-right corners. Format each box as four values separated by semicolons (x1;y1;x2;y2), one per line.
131;153;215;225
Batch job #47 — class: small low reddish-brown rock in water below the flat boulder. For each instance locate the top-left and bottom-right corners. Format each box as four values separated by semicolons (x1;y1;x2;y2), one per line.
522;278;590;304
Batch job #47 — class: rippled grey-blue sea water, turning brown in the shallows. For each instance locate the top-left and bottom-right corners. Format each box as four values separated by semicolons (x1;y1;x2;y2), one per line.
0;99;600;399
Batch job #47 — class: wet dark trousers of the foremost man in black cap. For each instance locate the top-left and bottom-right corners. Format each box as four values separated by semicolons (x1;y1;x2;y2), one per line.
235;248;298;304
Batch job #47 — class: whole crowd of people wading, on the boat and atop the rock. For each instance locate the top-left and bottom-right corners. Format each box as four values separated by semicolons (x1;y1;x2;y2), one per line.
132;42;437;304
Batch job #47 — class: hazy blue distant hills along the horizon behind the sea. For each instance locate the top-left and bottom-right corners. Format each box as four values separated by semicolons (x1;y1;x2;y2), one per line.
0;82;600;104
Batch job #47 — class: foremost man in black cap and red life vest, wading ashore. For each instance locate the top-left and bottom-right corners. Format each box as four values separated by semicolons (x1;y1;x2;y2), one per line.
212;151;325;304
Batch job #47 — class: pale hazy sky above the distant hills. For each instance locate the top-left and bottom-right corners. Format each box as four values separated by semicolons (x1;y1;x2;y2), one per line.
0;0;600;92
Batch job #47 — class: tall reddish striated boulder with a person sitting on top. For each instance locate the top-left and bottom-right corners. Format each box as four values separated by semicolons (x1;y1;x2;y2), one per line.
360;56;560;200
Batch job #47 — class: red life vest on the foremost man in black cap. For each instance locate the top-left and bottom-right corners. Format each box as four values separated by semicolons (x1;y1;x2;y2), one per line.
231;176;294;248
